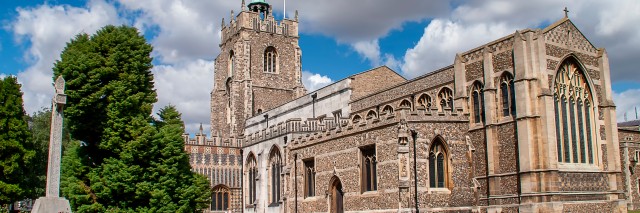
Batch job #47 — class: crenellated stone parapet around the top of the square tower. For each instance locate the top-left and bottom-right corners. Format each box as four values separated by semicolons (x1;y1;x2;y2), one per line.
220;11;298;45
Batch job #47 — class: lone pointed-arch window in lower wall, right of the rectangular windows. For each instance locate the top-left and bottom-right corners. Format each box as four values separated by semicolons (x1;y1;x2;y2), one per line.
429;138;448;188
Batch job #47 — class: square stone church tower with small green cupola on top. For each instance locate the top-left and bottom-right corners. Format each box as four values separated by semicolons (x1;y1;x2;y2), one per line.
211;0;306;139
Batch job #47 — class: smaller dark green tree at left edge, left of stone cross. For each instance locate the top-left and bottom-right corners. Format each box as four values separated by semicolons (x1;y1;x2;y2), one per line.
0;76;36;205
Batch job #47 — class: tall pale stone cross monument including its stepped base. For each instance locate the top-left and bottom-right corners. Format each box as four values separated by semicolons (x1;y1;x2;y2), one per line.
31;76;71;213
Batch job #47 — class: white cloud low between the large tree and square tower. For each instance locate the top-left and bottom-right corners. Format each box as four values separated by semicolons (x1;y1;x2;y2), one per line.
153;59;214;133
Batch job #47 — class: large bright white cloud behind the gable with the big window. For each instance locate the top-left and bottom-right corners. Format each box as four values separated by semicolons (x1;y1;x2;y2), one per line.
402;0;640;81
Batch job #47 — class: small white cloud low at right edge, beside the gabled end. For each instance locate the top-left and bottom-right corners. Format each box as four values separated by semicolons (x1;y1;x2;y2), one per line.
613;89;640;122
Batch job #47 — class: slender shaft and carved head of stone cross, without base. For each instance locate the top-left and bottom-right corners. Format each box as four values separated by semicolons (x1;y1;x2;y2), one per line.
46;76;67;197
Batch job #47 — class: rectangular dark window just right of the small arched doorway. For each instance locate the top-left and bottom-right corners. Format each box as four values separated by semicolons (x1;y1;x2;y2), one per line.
360;146;378;192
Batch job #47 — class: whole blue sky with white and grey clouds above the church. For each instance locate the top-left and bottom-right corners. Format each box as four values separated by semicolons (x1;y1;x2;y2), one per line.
0;0;640;132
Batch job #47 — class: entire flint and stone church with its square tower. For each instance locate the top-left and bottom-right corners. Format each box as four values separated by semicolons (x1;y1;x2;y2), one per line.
184;0;640;213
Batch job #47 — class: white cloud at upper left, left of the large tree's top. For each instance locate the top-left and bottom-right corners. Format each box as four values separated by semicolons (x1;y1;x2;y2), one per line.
5;0;122;114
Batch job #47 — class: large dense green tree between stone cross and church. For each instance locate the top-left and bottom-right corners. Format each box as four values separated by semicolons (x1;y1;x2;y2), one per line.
54;26;210;212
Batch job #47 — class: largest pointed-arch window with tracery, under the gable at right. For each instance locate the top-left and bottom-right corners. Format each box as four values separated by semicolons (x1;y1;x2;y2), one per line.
553;59;594;164
